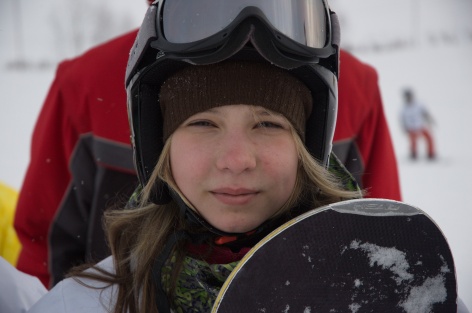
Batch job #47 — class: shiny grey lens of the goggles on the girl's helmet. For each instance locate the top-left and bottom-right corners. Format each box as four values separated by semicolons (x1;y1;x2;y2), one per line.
162;0;327;48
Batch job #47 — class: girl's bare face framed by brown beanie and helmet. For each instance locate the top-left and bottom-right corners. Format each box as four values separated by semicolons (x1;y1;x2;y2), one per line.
170;105;298;233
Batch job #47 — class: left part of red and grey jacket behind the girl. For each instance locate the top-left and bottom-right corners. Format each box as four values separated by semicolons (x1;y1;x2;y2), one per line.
15;32;136;286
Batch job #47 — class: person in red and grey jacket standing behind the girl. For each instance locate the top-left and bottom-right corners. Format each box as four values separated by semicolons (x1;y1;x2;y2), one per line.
15;20;401;287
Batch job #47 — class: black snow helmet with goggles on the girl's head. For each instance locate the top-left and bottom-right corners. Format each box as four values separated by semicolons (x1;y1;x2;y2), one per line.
125;0;340;204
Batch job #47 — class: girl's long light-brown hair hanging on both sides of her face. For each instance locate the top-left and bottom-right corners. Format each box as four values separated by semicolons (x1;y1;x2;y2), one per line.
74;123;360;313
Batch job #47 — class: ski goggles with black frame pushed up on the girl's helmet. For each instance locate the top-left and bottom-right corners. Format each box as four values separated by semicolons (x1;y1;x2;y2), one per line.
125;0;339;83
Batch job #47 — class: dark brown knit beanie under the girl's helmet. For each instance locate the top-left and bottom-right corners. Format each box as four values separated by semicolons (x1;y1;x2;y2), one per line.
160;61;312;141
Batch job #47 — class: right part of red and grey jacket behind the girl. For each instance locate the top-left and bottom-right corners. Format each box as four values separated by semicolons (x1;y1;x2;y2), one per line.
333;51;401;200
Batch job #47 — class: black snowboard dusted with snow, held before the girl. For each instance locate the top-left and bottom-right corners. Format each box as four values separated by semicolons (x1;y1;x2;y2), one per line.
212;199;457;313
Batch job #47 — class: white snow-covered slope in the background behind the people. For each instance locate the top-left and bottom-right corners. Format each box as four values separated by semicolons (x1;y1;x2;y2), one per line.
0;0;472;309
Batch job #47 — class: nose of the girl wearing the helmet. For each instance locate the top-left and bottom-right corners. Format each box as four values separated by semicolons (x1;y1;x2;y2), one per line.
215;133;257;174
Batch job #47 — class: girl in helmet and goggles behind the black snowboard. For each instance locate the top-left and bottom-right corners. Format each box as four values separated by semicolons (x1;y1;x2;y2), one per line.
28;0;361;313
